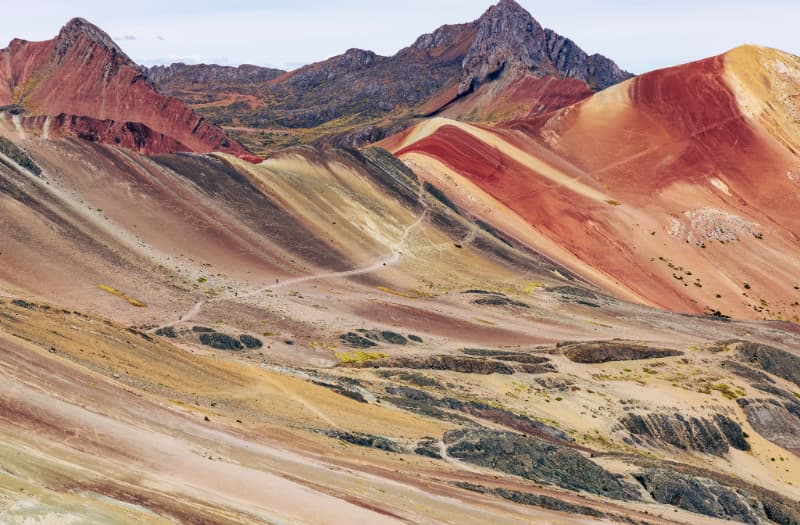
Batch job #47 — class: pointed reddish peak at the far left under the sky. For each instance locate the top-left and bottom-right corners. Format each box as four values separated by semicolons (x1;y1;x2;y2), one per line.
0;18;248;155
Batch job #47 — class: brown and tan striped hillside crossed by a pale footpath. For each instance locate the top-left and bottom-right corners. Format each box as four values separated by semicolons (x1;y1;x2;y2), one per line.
0;121;570;344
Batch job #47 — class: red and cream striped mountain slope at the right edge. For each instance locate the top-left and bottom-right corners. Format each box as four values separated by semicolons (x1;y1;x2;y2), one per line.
385;47;800;319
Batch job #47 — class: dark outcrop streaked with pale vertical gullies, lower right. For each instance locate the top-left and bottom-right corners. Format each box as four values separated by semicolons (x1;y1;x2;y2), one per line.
621;414;750;456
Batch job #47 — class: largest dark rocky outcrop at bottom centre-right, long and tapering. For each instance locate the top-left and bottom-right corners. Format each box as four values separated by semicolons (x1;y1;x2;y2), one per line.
444;430;638;500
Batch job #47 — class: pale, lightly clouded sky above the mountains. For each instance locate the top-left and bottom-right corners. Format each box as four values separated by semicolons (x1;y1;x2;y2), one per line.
0;0;800;73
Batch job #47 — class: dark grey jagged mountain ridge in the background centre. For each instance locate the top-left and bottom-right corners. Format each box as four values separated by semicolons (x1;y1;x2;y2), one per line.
150;0;631;148
